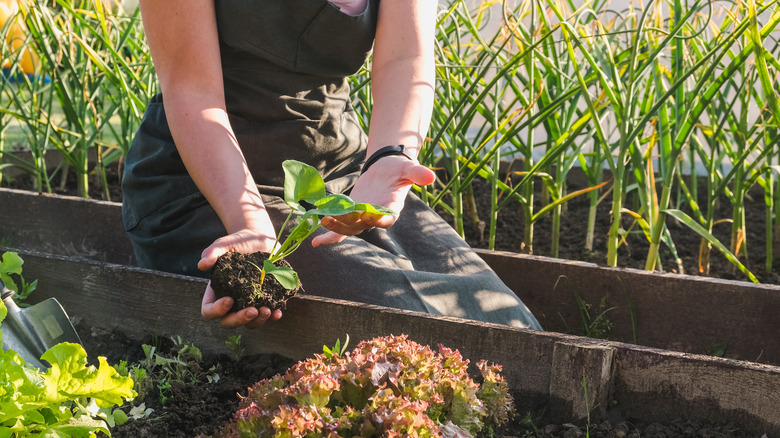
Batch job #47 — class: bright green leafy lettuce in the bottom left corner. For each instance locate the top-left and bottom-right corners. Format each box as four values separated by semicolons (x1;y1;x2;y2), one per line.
0;302;135;438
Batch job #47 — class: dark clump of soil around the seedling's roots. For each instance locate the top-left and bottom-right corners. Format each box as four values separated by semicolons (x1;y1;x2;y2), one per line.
211;252;301;311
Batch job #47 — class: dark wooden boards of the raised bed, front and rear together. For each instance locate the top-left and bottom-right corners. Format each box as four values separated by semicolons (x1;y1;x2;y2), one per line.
0;189;780;436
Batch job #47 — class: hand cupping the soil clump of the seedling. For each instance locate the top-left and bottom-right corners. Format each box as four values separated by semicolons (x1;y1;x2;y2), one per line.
198;229;282;329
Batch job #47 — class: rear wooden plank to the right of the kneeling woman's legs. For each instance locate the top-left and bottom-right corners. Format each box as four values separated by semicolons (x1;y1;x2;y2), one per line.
478;250;780;363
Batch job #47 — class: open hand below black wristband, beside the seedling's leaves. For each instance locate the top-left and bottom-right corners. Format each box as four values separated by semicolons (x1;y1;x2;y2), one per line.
312;155;436;246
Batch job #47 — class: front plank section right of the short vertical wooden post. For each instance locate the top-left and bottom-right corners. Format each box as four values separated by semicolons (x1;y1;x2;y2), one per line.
614;345;780;437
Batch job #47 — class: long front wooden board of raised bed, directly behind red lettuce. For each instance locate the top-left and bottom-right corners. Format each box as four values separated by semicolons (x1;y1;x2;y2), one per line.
6;251;780;436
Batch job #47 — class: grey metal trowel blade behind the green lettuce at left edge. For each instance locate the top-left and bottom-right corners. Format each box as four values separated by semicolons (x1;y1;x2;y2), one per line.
0;280;81;370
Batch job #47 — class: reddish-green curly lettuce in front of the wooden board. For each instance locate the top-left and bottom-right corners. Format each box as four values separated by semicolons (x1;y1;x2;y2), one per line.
204;335;514;438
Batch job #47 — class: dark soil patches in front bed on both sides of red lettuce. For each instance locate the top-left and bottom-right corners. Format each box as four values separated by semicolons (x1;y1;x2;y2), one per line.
82;323;758;438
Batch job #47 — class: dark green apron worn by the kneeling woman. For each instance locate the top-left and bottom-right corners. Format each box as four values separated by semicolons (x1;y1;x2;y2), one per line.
122;0;540;329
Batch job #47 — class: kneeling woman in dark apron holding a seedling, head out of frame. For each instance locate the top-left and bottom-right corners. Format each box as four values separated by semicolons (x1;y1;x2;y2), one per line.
123;0;539;329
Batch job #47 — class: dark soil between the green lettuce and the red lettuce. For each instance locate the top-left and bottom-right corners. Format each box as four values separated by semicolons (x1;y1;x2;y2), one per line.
76;324;294;438
